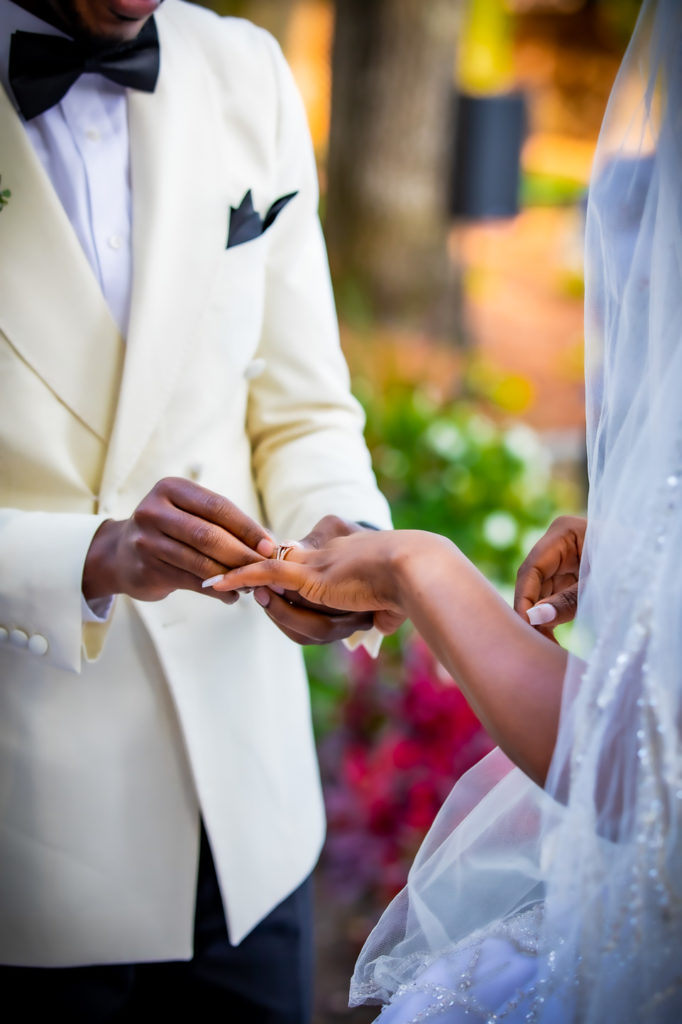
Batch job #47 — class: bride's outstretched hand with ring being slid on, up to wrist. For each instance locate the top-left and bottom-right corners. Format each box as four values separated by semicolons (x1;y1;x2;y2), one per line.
206;530;407;633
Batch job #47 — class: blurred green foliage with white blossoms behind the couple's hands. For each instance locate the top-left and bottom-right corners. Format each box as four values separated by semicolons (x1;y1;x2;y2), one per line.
355;381;558;586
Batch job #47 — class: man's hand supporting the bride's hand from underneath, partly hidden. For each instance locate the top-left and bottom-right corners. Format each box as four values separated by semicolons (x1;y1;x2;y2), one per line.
248;515;403;645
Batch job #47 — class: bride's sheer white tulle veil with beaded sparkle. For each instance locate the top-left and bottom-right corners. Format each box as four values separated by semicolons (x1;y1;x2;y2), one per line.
350;0;682;1024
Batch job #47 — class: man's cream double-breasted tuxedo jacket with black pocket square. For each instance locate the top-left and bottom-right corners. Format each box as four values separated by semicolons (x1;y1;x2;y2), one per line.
0;0;389;966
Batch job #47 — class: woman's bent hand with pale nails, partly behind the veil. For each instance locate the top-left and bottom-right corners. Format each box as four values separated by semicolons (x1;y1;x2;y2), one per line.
514;515;587;640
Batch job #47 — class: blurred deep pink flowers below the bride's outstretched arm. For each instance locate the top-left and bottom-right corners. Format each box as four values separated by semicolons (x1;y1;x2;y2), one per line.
321;634;493;902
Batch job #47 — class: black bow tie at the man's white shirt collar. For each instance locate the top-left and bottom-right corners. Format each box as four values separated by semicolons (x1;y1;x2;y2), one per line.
9;17;159;121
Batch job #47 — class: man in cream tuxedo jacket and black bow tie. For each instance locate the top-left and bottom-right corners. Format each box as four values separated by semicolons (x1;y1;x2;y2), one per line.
0;0;389;1024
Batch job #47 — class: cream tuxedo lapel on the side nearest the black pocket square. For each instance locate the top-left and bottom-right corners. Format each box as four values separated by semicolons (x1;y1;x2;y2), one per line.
102;17;229;492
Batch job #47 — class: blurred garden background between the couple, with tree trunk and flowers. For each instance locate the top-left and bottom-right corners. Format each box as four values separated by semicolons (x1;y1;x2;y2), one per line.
192;0;639;1024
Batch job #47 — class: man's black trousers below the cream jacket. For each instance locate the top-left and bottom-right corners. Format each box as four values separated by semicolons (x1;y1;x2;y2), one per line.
0;828;313;1024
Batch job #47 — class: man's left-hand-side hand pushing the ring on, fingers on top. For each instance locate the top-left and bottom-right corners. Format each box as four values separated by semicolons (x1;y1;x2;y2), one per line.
83;477;274;604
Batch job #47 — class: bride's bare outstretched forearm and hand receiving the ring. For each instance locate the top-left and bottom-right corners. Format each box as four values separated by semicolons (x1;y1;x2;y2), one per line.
209;530;567;785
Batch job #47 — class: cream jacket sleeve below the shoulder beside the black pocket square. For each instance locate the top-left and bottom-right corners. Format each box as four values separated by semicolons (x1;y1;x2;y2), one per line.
248;37;390;537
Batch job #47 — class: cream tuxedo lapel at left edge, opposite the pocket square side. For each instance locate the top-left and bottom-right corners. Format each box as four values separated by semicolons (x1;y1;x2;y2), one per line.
0;86;123;440
